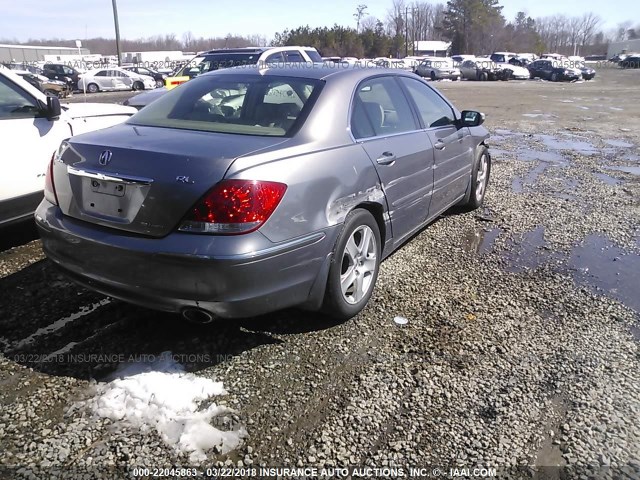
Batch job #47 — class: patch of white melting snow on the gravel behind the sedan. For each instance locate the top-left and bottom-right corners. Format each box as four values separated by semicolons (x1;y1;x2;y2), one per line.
72;352;247;462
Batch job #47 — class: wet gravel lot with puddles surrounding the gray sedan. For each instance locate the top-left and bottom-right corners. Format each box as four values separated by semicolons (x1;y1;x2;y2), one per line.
0;65;640;478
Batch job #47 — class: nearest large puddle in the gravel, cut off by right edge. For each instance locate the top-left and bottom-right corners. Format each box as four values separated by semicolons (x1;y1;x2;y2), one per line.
569;234;640;312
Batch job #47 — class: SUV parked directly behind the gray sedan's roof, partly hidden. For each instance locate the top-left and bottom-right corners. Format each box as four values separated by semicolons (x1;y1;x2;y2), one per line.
165;46;323;90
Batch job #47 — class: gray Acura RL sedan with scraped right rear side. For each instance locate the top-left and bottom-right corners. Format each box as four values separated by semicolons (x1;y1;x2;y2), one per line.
36;64;491;323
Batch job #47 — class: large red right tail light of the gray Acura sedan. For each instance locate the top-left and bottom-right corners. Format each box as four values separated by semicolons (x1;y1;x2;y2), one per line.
179;180;287;235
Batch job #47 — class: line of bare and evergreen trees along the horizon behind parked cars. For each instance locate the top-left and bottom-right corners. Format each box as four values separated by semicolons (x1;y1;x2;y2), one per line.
0;0;640;58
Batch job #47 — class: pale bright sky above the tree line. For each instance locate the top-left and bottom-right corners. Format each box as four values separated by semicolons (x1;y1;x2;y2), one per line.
0;0;640;41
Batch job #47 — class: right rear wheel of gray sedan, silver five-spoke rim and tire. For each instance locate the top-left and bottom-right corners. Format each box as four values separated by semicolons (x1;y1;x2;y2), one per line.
322;209;382;320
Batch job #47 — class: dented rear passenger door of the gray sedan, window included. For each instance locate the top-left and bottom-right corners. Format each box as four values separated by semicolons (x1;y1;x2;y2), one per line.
351;76;433;241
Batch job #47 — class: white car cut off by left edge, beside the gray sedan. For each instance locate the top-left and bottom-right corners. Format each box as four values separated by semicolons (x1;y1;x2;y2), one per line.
0;66;136;227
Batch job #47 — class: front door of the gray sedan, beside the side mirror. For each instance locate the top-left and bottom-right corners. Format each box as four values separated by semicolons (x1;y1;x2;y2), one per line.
400;77;474;216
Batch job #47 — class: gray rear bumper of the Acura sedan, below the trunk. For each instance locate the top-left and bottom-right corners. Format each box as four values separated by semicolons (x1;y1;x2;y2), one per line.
36;200;339;318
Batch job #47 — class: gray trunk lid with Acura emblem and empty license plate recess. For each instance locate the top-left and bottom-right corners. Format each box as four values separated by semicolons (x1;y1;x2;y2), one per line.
54;124;287;237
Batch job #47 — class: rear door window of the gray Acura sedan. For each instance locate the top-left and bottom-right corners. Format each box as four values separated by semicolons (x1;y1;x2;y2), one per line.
351;77;418;138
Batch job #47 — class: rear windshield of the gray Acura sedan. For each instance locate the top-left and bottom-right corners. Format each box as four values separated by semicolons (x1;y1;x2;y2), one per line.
127;75;322;137
